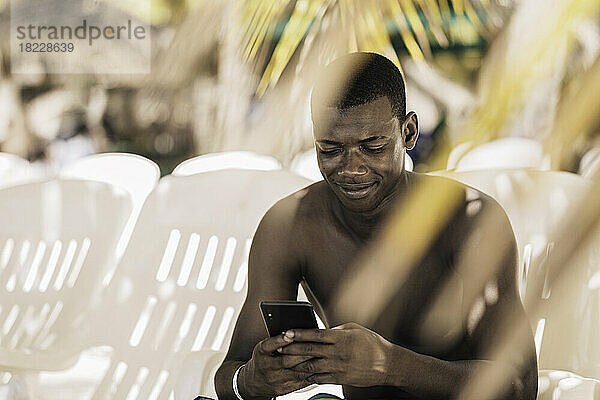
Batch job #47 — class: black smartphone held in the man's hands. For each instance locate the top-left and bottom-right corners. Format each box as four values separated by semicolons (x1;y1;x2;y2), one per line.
260;301;318;337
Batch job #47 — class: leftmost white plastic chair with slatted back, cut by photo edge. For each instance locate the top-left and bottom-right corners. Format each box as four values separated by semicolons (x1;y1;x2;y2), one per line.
0;180;131;372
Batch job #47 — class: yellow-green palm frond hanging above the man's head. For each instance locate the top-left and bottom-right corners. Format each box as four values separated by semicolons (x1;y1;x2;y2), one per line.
240;0;506;96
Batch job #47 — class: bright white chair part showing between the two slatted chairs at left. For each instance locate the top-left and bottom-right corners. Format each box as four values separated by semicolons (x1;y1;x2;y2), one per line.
59;153;160;262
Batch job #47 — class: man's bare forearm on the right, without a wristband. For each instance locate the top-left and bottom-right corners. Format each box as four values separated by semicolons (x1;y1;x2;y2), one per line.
386;346;535;400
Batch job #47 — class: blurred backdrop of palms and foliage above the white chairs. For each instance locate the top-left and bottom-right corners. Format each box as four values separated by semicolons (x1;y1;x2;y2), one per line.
0;0;600;175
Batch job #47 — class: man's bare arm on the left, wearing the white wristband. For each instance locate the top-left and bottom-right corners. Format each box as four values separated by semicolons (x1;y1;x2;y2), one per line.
215;198;309;400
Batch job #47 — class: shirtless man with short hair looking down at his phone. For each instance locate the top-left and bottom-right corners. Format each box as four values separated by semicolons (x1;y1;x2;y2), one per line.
215;53;537;400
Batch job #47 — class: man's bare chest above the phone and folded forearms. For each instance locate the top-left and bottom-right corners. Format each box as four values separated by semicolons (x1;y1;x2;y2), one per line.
303;225;463;354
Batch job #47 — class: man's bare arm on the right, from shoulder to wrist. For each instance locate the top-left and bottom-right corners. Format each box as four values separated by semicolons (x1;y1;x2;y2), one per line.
378;217;537;400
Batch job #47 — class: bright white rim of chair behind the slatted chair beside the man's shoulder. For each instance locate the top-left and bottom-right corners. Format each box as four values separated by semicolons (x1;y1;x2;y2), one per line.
171;151;281;176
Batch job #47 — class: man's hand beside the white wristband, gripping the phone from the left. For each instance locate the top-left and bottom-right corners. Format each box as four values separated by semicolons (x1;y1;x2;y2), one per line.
238;335;313;398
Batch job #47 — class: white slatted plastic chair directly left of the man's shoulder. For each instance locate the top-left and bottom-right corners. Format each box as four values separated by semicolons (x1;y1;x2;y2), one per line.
53;170;310;399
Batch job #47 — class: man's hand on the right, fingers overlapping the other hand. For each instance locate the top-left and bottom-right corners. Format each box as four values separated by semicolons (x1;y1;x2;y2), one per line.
278;323;393;387
